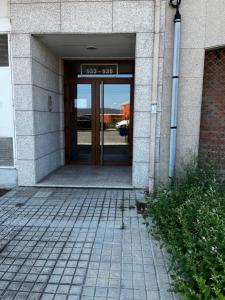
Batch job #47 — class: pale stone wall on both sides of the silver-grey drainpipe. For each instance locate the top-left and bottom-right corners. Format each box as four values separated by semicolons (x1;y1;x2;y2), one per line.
157;0;225;182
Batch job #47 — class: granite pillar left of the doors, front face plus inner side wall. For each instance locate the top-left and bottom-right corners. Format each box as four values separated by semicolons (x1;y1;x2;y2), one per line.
12;34;63;185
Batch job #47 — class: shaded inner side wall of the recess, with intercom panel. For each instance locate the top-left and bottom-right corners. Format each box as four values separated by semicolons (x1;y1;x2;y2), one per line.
31;37;63;181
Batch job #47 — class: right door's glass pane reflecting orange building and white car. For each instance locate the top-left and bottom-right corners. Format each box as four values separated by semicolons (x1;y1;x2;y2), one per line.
100;84;131;164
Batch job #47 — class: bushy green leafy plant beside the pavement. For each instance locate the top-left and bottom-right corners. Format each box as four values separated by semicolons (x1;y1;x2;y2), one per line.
146;161;225;300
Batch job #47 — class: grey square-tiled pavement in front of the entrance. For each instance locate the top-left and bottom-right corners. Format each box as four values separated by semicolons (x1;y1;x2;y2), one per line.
0;188;173;300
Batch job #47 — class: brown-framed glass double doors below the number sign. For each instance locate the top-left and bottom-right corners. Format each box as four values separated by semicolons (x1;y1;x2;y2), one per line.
65;64;133;165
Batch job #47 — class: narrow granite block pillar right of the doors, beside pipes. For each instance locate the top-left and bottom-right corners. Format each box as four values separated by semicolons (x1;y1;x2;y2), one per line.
133;32;154;188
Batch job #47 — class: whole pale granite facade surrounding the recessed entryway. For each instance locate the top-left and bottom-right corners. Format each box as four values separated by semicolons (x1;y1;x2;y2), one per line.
0;0;225;189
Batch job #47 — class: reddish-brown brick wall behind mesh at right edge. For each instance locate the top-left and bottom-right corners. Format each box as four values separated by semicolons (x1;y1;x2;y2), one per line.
199;48;225;170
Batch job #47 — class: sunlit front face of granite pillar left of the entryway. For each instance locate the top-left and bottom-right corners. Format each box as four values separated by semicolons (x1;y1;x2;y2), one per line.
12;33;36;185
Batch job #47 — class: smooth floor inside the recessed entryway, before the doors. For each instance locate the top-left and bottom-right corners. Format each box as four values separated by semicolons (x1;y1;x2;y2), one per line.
37;165;132;188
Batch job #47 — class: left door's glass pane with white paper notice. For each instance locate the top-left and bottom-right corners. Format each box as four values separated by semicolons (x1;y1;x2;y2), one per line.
71;83;93;162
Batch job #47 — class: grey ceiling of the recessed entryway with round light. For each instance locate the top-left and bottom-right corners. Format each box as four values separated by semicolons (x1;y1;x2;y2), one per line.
37;34;135;59
